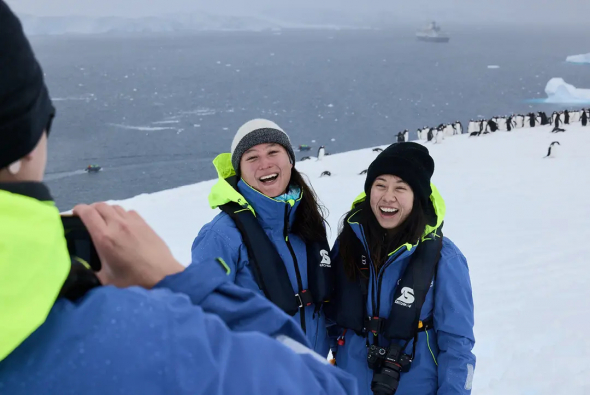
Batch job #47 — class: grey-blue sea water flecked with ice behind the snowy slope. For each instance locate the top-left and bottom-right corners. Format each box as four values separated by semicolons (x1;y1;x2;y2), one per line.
32;27;590;210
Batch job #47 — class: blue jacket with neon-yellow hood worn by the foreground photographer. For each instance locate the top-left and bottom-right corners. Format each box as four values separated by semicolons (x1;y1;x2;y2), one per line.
0;184;356;395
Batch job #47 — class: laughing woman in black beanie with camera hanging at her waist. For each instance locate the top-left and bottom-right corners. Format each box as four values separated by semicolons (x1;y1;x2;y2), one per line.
326;142;475;395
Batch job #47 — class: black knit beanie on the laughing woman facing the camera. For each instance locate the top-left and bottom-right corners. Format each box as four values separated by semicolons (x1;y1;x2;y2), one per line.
365;142;434;209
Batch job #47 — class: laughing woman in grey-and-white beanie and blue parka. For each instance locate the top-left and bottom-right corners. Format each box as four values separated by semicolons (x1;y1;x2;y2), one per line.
192;119;331;357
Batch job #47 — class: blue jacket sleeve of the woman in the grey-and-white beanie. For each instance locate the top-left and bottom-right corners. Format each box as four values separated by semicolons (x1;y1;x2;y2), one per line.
191;224;260;291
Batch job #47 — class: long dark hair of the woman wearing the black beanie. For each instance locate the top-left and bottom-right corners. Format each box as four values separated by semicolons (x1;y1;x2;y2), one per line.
338;196;428;280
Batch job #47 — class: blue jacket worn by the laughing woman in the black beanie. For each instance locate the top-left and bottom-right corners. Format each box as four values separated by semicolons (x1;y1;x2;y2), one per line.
331;186;475;395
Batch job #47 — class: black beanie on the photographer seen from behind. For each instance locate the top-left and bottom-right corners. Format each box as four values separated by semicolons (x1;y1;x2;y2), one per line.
0;0;55;169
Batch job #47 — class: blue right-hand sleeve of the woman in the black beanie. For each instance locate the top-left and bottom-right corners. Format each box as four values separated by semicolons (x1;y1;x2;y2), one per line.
434;241;475;395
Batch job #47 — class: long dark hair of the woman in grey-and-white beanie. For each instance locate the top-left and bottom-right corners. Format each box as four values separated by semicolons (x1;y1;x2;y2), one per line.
291;168;328;243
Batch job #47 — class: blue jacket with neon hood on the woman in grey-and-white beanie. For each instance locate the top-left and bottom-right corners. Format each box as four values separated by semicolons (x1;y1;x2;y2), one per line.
192;154;330;357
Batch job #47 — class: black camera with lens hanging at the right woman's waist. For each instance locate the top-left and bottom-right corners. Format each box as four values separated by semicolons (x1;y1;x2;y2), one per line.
367;344;412;395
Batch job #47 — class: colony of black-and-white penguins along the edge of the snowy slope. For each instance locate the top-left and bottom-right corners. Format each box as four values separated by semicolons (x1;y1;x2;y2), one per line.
312;108;590;177
